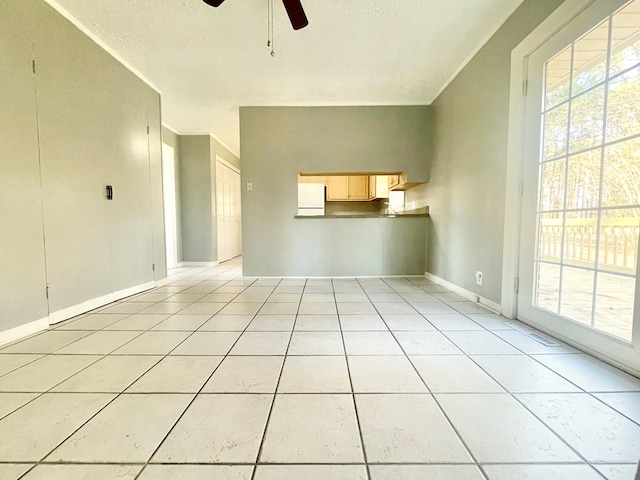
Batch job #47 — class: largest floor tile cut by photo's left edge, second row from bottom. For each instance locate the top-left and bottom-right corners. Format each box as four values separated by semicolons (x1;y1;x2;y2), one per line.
0;393;114;462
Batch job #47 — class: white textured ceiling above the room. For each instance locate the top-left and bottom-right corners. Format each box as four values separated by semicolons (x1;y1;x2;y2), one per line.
49;0;523;153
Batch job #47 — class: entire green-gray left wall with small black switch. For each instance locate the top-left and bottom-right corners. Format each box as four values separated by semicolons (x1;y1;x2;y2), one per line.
0;0;166;338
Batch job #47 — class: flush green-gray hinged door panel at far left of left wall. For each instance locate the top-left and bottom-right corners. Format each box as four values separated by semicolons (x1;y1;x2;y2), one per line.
0;0;48;332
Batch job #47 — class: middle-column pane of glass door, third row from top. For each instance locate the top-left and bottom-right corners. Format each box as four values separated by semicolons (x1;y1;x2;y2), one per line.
567;149;602;209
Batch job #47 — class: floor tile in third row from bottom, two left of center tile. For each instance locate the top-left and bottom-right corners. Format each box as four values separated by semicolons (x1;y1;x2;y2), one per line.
127;355;224;393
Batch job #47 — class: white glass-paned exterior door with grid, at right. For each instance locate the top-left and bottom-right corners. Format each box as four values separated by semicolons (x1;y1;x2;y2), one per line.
518;0;640;372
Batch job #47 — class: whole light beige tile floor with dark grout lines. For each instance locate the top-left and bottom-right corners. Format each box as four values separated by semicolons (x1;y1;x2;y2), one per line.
0;260;640;480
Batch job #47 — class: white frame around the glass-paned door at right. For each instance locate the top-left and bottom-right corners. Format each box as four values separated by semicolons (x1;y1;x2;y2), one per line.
501;0;640;374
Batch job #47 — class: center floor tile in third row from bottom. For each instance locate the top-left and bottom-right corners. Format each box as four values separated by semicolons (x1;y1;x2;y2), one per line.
278;356;351;393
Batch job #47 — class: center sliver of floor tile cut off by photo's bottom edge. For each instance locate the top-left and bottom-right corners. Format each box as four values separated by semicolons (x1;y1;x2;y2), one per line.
255;465;368;480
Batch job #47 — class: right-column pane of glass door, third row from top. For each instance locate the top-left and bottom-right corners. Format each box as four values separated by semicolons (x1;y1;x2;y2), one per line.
602;139;640;207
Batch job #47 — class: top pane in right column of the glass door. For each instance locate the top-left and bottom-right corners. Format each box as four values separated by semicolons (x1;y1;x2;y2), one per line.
609;0;640;76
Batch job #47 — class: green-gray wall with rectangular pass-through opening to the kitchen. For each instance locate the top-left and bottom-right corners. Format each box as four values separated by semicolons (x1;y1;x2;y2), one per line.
240;106;431;276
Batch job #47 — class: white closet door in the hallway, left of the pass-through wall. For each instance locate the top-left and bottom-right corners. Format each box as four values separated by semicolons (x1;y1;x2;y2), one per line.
216;159;242;262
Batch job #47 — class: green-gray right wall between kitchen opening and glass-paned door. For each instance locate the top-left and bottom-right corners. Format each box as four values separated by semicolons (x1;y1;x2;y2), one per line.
426;0;562;303
